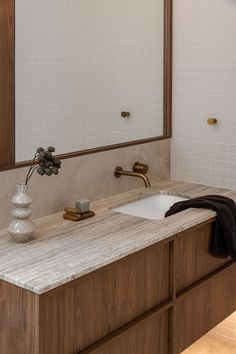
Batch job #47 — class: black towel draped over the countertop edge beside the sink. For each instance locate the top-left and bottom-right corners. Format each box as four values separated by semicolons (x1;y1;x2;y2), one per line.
165;195;236;260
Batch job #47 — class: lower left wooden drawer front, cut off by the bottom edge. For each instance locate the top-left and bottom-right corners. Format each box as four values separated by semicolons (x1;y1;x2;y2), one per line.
81;311;169;354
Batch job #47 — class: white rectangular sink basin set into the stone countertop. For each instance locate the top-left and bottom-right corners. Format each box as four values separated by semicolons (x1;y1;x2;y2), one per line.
113;194;188;220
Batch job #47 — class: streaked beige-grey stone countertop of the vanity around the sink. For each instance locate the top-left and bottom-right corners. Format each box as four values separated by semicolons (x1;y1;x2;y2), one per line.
0;181;236;294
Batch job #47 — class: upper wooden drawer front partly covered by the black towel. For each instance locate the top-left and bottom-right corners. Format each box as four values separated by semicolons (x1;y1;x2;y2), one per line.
175;222;230;292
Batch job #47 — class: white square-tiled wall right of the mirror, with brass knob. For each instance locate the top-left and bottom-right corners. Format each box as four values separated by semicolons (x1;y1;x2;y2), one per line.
172;0;236;189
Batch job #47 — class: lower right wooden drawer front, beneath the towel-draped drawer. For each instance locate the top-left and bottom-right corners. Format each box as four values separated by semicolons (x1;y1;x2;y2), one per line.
175;263;236;353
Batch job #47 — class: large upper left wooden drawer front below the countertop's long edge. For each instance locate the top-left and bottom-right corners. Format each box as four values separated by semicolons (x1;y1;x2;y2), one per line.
42;243;170;354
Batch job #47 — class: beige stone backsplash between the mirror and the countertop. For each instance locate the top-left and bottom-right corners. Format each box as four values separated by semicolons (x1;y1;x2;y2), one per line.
0;139;170;228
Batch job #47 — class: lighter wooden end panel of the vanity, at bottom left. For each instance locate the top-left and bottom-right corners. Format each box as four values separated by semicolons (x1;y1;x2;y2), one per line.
0;281;40;354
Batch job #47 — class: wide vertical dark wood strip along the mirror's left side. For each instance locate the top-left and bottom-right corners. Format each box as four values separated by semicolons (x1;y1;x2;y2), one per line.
0;0;15;167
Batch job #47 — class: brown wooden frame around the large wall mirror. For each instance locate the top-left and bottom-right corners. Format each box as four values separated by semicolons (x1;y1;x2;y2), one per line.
0;0;173;171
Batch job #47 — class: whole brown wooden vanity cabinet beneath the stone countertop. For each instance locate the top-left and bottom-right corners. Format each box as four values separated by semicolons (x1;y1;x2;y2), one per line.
0;219;236;354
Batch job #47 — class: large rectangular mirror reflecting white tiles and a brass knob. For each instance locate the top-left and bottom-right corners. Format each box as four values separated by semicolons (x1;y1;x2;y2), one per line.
0;0;171;169
